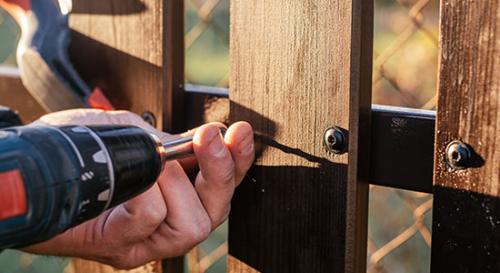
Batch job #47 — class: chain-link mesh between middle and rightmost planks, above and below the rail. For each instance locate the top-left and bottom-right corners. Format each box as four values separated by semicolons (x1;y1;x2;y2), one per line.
368;0;439;268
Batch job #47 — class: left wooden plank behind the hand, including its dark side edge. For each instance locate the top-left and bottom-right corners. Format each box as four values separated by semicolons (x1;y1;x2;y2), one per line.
66;0;184;273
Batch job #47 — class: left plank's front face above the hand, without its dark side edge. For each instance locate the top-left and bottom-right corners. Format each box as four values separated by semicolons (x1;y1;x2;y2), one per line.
70;0;167;127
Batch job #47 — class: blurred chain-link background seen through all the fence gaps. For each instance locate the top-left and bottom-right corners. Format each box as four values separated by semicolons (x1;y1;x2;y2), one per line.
0;0;439;273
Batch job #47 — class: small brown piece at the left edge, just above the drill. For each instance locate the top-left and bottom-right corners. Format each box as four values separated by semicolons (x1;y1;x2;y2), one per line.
0;74;45;123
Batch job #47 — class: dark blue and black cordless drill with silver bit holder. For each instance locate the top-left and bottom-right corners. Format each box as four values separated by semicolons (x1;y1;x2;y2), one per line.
0;125;199;249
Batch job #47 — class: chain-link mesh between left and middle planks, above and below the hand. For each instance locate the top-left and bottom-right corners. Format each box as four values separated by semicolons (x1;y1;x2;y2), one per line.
185;0;229;273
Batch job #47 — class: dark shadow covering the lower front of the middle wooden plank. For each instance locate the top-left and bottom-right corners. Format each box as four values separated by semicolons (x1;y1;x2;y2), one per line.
229;159;347;272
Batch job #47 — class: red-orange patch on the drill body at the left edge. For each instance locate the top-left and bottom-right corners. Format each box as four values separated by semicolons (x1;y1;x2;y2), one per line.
0;170;28;221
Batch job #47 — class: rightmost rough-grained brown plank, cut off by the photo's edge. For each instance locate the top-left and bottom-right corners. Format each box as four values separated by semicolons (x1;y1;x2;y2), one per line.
431;0;500;273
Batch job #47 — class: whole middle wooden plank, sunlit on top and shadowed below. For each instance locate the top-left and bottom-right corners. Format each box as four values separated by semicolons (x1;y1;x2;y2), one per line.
229;0;373;272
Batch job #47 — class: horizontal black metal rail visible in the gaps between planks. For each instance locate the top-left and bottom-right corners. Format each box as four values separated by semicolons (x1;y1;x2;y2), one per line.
185;85;436;193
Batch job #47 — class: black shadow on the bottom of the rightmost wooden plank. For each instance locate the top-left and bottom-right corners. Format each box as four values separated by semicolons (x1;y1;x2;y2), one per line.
431;186;500;273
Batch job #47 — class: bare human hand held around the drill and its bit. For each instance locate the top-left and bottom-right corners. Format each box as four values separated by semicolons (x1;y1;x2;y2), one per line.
23;109;254;269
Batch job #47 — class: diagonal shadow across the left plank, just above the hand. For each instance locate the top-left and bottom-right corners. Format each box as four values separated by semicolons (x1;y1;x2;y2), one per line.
70;31;161;115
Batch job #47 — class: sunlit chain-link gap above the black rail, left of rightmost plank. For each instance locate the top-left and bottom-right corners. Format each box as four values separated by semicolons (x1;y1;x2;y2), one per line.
373;0;439;109
